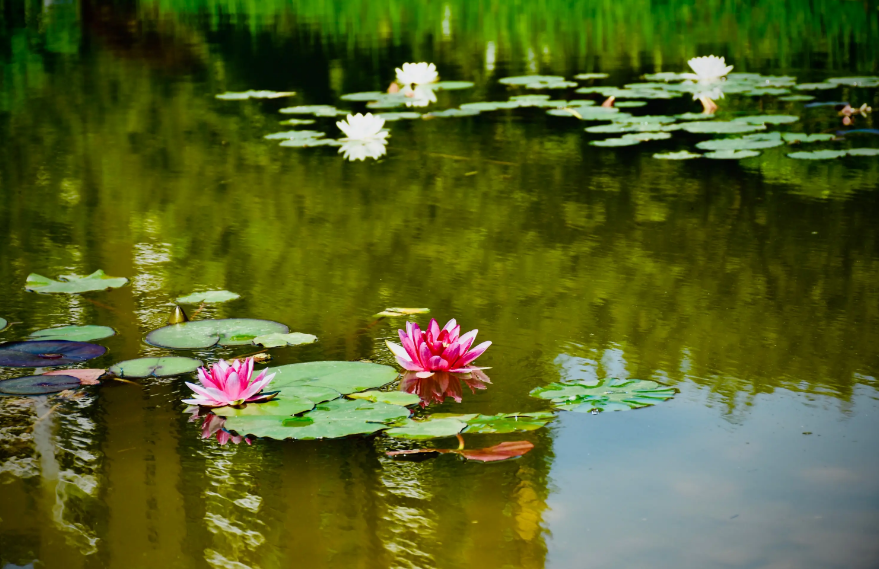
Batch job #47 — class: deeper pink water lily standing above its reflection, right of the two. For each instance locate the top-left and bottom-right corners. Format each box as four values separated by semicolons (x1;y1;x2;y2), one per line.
386;318;491;378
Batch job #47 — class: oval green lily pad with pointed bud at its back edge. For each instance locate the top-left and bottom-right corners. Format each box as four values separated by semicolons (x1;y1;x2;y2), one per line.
146;318;290;350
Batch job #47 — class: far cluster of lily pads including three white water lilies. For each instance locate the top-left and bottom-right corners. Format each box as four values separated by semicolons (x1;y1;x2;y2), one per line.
218;56;879;160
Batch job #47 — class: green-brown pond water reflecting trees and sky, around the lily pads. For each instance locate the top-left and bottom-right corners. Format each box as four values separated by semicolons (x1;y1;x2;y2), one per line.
0;0;879;569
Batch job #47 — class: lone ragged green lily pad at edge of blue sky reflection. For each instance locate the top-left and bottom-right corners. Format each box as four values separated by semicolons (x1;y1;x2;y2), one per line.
531;379;675;413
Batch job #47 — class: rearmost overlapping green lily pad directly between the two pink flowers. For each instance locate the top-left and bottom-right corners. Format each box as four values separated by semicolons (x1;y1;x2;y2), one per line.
269;362;398;395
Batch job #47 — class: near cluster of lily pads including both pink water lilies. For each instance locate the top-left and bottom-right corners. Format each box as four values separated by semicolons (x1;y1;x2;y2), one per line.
0;271;675;462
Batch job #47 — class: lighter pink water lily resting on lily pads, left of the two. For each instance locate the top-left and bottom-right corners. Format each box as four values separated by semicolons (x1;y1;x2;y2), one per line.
183;358;277;407
